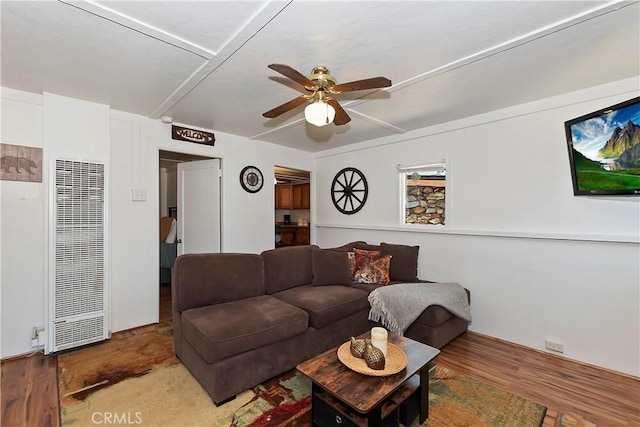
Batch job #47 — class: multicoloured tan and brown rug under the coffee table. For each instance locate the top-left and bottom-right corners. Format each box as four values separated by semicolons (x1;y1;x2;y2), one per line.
53;327;593;427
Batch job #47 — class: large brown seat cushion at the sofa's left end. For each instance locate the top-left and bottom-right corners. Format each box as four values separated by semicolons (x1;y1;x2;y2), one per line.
182;295;309;363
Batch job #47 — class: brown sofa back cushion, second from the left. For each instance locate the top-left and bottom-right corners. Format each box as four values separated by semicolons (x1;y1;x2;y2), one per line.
261;245;318;294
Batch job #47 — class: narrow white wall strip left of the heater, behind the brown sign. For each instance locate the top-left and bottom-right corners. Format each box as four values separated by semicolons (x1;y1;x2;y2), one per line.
0;89;46;357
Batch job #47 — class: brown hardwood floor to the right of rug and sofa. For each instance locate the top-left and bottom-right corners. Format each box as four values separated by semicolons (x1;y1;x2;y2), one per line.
436;333;640;427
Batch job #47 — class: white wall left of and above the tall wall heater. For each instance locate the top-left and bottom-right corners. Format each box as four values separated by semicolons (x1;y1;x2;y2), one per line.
1;93;110;357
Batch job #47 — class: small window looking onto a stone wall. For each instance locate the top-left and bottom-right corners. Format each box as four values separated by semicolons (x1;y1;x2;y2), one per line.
398;160;446;225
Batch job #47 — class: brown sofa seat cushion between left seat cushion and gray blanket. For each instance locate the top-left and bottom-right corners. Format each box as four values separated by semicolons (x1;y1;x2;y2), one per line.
273;285;370;328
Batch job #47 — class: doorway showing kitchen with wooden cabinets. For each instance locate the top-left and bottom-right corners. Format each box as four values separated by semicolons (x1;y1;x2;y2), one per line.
274;166;311;247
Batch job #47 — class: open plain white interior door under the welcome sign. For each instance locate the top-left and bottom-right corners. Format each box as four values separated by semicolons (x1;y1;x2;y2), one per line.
177;159;222;255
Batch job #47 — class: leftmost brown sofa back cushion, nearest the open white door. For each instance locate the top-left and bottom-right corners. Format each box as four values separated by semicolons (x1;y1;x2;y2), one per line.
172;253;265;311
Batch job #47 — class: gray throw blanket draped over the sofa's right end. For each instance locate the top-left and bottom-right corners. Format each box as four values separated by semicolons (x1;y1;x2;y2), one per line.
369;283;471;334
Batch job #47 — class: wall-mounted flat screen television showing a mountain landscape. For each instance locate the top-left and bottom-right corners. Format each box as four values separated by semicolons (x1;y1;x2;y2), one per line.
564;97;640;196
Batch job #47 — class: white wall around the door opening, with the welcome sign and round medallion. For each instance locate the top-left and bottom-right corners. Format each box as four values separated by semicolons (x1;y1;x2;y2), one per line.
111;111;313;331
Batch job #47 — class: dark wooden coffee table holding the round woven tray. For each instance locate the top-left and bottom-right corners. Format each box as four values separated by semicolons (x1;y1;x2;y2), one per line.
297;333;440;426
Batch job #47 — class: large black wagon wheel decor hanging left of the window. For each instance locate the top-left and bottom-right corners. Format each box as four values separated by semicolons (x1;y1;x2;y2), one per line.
331;168;369;215
